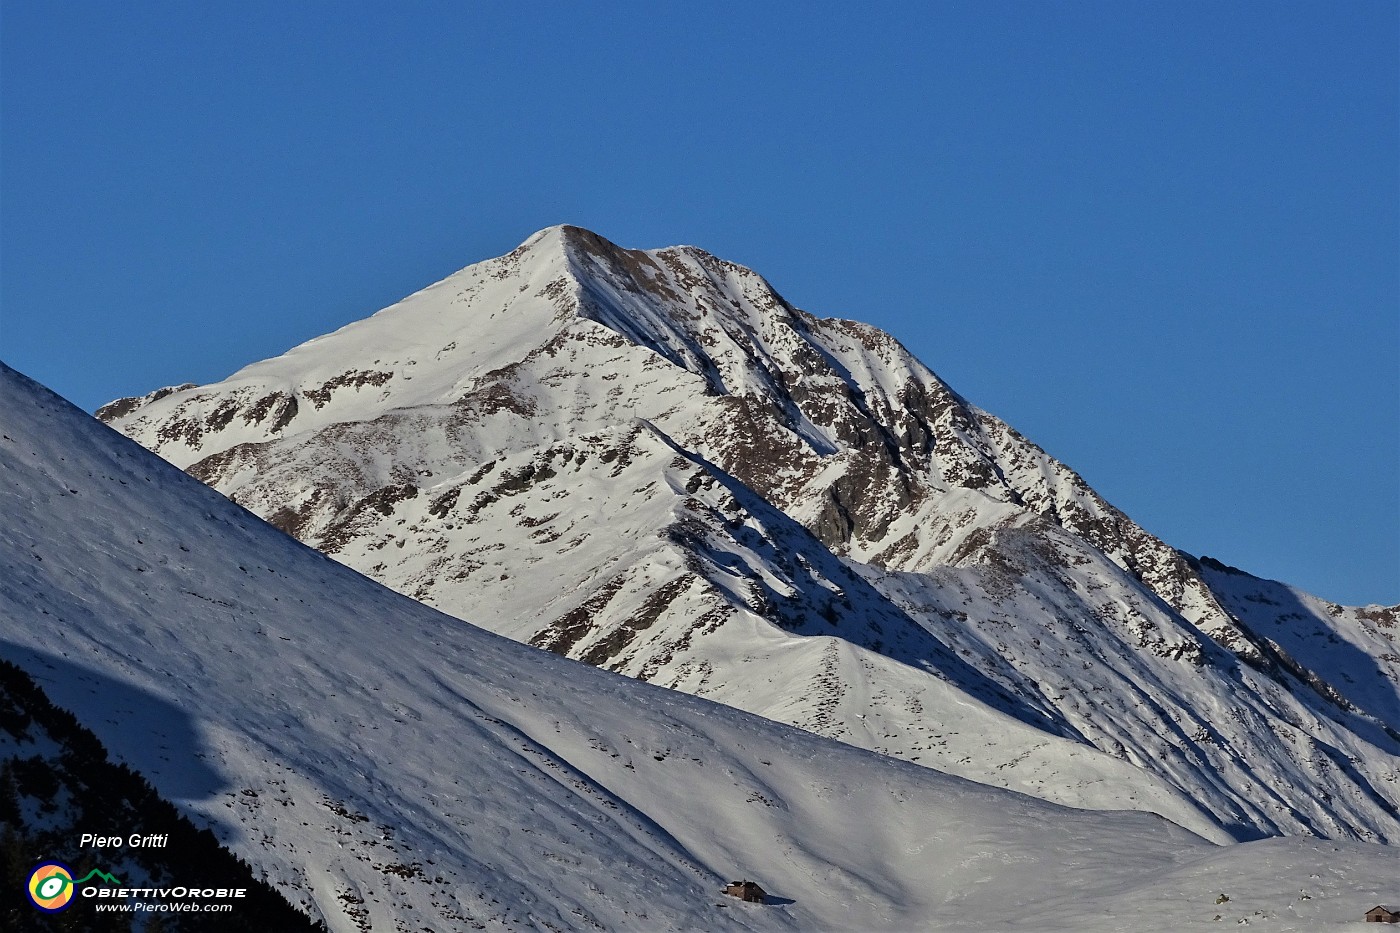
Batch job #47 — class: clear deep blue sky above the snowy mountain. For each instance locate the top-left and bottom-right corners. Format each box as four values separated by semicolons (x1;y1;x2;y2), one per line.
0;0;1400;602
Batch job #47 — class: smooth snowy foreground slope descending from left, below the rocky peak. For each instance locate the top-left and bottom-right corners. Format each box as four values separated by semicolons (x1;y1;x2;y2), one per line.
0;367;1400;932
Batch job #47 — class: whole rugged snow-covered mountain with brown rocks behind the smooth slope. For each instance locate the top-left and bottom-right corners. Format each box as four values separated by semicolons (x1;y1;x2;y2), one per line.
98;227;1400;841
